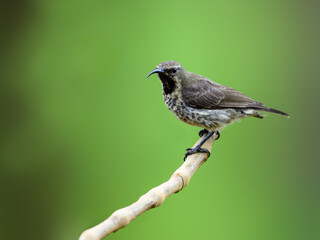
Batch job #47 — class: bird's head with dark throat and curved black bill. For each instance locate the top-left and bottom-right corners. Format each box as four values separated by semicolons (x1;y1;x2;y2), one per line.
147;61;185;94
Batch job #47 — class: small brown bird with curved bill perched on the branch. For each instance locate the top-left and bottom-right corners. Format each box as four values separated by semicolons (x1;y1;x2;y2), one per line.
146;61;290;159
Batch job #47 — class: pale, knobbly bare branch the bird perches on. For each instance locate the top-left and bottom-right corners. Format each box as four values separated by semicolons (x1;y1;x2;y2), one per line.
79;134;216;240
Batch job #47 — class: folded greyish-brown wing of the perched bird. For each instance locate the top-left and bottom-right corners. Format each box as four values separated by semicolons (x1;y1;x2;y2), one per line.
182;78;263;109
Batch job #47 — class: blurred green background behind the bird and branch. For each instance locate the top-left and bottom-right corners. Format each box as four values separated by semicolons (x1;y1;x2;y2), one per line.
0;0;320;240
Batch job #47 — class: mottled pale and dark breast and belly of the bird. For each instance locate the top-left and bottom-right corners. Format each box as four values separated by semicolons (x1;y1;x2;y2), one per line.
165;95;239;130
